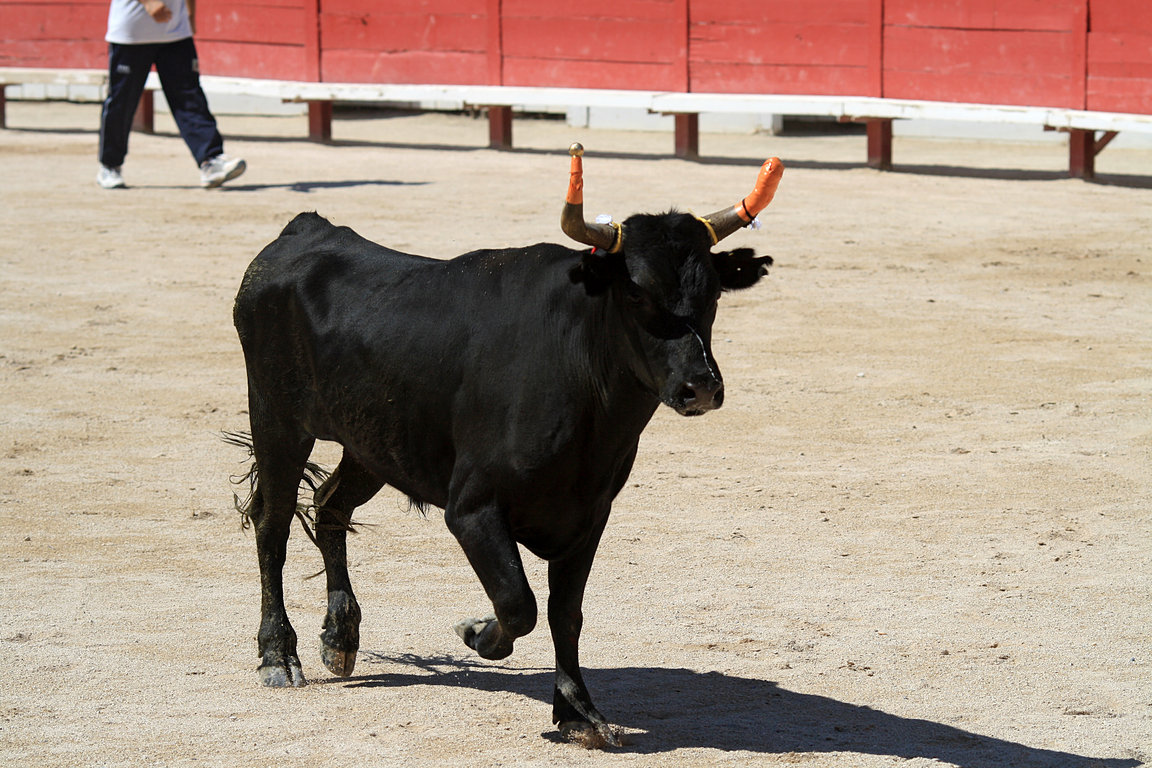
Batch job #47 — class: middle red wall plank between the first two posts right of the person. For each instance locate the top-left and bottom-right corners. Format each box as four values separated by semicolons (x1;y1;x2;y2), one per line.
320;13;487;52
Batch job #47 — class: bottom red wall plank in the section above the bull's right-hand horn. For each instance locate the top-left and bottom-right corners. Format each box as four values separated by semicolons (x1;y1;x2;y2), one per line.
691;62;869;96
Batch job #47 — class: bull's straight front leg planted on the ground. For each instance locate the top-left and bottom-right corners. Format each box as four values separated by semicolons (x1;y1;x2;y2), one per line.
548;515;621;750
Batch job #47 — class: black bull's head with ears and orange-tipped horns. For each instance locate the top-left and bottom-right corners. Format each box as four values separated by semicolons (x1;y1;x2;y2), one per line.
560;144;783;416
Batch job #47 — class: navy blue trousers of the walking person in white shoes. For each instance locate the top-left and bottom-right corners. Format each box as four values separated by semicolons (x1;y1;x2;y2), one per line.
100;37;223;168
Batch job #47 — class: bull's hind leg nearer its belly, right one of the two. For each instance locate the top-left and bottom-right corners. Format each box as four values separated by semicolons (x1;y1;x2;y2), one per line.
316;454;384;677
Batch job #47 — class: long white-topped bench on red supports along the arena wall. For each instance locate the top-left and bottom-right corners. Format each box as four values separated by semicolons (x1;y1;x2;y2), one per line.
0;68;1152;178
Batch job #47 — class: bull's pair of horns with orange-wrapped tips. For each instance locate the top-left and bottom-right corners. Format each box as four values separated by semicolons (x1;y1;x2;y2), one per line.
560;144;785;253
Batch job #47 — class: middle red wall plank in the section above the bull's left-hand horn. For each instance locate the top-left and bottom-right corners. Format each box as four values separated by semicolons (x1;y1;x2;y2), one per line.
503;18;684;63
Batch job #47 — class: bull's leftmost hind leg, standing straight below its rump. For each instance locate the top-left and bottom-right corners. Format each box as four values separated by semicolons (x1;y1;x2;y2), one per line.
251;421;314;687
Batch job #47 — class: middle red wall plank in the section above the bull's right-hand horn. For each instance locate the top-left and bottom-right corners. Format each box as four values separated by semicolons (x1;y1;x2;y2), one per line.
690;24;869;67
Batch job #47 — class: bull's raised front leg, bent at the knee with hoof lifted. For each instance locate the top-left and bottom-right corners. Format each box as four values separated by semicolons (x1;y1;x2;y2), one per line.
445;485;537;660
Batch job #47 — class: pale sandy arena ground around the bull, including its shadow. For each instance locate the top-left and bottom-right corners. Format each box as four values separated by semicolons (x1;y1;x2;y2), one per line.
0;102;1152;768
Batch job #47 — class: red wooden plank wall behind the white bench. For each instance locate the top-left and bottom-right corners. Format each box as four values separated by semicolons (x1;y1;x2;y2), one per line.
0;0;1152;114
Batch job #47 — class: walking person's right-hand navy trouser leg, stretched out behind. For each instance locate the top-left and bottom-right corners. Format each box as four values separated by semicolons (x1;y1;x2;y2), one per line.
156;38;223;166
